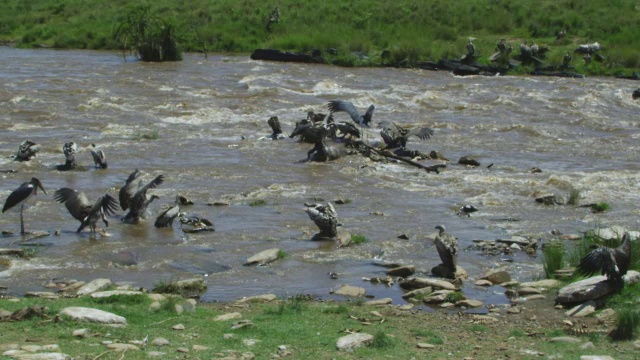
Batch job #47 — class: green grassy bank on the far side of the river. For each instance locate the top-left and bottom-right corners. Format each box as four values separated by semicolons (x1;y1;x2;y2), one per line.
0;0;640;75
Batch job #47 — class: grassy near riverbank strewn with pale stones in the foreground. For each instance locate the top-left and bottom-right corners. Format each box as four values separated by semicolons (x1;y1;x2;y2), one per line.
0;295;635;359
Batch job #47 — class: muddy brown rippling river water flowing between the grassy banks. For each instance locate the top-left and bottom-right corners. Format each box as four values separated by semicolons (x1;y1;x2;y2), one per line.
0;47;640;303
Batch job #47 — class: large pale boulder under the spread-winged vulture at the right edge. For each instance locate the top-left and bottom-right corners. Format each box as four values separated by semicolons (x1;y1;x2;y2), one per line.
556;270;640;304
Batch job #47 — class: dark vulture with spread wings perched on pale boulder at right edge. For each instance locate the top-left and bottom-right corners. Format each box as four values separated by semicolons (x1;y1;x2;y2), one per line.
578;233;631;289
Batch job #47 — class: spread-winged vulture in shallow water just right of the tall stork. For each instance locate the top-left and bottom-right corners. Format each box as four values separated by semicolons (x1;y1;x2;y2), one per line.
53;188;118;233
